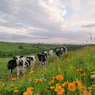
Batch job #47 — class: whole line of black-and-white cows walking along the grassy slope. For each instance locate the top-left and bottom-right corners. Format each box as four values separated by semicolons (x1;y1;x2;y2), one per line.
7;47;67;77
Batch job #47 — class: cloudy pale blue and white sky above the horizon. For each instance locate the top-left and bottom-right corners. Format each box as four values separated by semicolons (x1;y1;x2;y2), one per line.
0;0;95;44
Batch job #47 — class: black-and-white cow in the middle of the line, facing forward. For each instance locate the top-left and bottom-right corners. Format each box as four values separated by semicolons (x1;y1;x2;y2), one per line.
37;51;48;67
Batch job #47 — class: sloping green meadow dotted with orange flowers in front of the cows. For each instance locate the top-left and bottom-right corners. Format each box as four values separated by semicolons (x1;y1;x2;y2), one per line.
0;46;95;95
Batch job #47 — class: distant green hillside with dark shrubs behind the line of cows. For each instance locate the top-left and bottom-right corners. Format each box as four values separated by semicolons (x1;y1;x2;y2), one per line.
0;42;85;58
